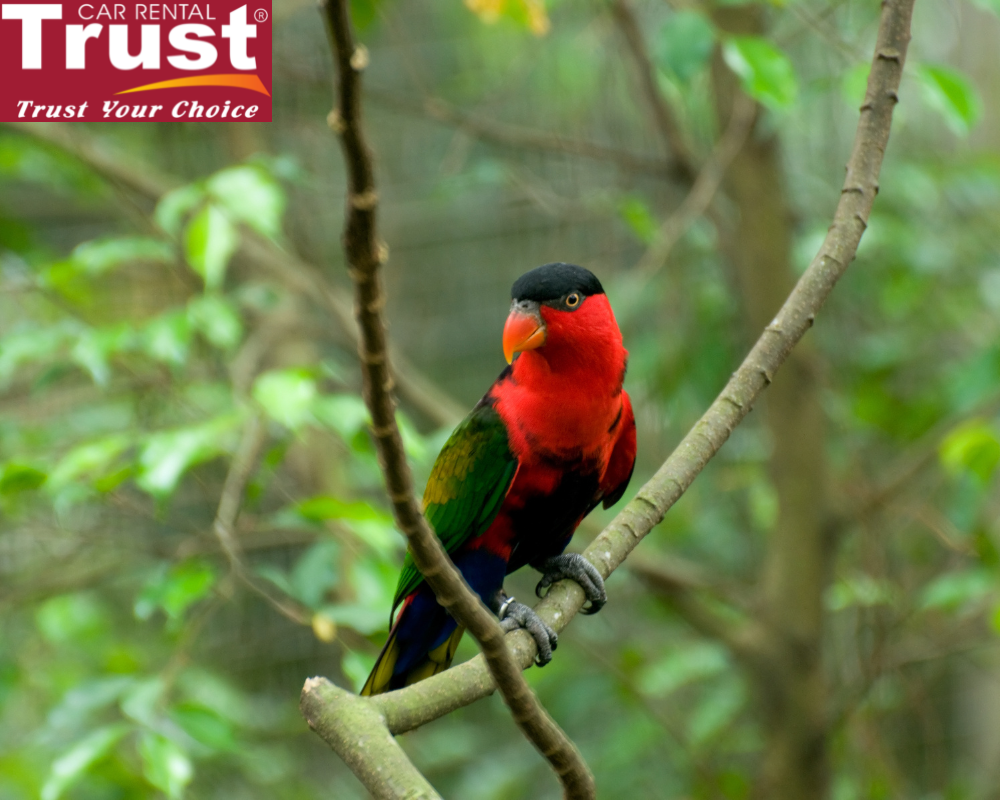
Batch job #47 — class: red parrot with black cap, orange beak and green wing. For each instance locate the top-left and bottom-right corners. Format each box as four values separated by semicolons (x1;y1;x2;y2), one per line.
361;263;636;695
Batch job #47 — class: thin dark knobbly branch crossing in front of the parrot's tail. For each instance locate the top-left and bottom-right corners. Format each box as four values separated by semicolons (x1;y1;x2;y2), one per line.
303;0;596;798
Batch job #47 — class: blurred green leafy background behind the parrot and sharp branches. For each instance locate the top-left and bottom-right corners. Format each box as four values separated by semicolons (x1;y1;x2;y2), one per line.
0;0;1000;800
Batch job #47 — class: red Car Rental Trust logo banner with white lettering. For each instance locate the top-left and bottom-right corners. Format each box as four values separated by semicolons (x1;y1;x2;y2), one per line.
0;0;271;122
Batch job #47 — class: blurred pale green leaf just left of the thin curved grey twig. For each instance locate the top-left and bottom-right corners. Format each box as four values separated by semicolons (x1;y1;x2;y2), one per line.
136;414;241;497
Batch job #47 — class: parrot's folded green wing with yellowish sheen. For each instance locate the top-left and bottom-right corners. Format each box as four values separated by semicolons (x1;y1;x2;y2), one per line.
392;404;517;613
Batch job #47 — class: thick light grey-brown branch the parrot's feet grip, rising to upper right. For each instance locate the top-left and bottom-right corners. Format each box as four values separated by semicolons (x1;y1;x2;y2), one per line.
302;0;913;733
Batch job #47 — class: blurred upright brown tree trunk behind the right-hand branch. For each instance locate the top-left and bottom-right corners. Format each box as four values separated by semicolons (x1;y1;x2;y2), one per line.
712;6;830;800
